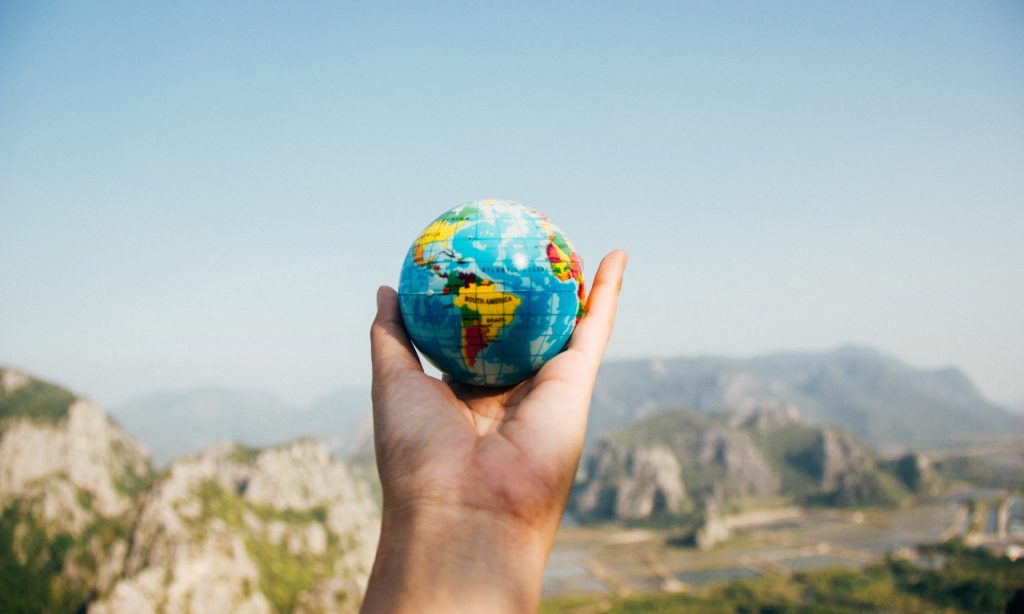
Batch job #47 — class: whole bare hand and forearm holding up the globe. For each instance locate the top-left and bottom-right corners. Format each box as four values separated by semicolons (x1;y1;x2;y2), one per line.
362;250;627;613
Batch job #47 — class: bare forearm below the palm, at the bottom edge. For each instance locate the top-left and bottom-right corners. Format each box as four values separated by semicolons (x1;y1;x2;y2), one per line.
362;503;556;613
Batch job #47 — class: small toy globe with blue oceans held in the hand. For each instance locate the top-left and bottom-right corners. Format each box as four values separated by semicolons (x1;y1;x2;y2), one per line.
398;199;584;386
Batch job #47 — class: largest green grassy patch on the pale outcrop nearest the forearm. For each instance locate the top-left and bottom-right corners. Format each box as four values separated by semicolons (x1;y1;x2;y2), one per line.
193;480;335;612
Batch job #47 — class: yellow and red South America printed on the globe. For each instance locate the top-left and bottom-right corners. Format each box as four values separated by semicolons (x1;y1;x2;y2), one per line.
452;279;522;367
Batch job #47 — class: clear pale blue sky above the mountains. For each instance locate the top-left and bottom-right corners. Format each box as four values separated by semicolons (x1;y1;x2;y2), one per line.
0;1;1024;405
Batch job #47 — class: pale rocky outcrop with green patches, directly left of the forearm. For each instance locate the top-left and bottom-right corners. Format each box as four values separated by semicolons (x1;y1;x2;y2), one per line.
89;441;379;614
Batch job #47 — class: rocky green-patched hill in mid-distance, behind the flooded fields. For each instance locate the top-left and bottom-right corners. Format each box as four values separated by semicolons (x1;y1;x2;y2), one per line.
571;407;938;548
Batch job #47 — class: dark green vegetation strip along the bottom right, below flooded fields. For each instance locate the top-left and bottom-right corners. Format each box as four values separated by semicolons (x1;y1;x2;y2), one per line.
541;540;1024;613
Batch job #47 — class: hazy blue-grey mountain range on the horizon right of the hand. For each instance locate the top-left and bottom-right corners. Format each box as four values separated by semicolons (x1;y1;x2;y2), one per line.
588;346;1024;447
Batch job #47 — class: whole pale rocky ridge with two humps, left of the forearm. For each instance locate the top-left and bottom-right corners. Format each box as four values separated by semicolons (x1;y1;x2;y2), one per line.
0;368;380;614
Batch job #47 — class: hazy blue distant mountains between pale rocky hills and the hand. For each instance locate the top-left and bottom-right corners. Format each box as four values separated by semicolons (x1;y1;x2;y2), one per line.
111;388;371;465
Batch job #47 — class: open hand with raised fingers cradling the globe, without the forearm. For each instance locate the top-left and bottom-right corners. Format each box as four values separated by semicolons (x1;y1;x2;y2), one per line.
371;251;627;533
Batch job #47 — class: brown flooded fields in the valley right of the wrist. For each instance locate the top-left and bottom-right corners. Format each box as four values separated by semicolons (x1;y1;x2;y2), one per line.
544;499;964;597
